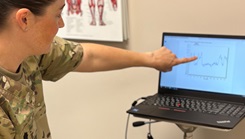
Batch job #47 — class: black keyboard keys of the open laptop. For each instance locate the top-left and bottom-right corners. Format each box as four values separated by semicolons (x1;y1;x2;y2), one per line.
144;96;245;117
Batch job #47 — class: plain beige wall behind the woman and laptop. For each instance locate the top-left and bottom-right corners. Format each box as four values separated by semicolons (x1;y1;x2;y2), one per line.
44;0;245;139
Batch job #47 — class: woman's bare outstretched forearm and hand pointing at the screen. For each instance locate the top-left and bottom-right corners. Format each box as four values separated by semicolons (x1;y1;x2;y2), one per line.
75;43;196;72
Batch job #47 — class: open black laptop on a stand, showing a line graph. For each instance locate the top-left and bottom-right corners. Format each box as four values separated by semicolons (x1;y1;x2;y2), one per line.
127;32;245;130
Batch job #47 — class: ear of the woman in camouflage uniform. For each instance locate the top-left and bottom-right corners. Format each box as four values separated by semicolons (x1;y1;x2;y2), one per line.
15;8;33;31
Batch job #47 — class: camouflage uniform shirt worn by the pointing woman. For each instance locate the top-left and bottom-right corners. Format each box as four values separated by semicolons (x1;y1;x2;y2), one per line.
0;37;83;139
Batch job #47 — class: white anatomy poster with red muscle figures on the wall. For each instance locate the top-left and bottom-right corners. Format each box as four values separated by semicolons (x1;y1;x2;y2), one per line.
57;0;123;41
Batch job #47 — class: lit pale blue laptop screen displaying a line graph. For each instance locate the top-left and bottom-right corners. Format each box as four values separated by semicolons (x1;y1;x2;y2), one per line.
159;33;245;96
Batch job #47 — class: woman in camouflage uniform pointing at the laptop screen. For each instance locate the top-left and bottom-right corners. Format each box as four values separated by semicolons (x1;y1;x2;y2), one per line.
0;0;196;139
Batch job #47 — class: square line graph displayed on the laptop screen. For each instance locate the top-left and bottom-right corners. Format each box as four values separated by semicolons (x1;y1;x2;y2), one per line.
186;44;229;80
